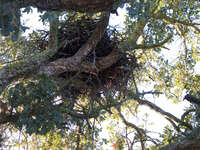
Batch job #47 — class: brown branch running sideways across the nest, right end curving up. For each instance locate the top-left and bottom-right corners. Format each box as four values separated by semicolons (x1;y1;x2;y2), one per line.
40;50;120;75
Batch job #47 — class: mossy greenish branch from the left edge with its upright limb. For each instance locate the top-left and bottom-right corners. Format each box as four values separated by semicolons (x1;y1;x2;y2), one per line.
0;18;58;93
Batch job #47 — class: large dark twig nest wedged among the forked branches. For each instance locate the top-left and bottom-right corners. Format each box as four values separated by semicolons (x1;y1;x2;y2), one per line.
36;16;137;97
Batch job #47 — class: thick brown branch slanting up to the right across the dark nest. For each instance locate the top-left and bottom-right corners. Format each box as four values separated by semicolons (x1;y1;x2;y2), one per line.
40;12;110;75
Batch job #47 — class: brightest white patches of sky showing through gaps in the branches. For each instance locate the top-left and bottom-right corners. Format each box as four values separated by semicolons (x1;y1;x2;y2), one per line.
7;9;195;150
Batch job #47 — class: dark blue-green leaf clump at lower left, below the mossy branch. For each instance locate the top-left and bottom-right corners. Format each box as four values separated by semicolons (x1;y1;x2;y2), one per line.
6;75;63;134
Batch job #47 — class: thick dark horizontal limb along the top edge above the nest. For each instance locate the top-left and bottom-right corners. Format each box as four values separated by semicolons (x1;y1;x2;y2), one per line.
18;0;116;12
